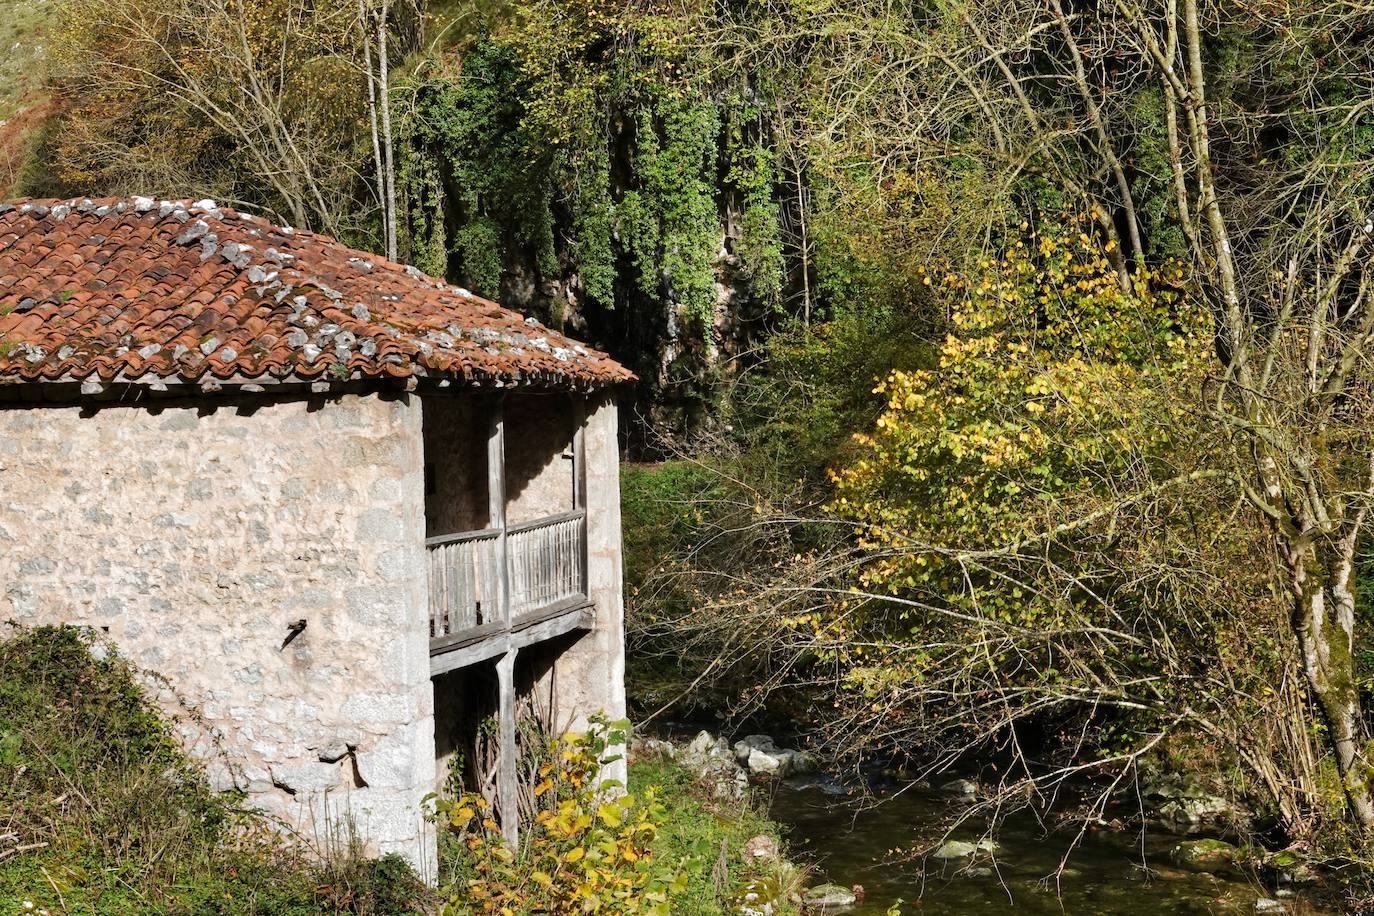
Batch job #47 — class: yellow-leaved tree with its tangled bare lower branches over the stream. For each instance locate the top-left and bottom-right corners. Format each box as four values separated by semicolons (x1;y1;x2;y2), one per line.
802;225;1311;816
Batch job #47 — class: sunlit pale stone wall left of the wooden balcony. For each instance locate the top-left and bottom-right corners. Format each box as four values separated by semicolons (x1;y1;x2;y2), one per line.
0;396;434;869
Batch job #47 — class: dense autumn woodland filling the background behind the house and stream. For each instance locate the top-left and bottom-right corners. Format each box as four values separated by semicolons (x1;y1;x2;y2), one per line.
8;0;1374;900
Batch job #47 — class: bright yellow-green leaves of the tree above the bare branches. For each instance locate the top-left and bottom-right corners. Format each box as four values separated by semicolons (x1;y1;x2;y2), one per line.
834;222;1212;615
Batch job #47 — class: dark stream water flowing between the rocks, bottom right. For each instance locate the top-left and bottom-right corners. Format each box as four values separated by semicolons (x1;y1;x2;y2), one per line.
771;781;1327;916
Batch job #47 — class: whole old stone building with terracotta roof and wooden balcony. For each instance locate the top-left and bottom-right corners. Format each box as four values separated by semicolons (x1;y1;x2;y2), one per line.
0;198;632;869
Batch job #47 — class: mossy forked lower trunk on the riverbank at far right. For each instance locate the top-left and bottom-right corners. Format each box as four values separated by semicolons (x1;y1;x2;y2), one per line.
1281;526;1374;828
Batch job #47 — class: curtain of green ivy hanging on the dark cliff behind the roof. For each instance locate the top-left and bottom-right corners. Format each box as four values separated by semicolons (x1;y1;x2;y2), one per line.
401;0;785;336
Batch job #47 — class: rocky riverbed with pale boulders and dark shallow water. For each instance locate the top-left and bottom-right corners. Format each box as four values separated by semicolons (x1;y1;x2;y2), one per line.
638;732;1327;916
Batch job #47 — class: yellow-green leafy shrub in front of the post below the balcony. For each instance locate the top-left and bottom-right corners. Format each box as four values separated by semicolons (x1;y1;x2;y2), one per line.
434;718;684;916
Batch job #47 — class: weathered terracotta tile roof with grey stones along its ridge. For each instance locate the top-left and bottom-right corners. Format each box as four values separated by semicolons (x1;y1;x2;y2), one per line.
0;198;633;387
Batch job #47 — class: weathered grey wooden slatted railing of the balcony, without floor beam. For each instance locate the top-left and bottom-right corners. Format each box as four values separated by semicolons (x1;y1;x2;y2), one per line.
426;509;587;639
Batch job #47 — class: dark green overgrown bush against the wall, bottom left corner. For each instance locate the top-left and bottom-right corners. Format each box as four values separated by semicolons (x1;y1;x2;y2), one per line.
0;628;425;916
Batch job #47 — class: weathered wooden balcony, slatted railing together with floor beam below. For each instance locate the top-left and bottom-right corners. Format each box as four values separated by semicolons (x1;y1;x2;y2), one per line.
426;509;591;674
